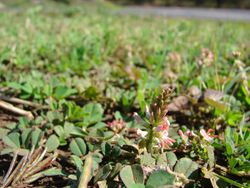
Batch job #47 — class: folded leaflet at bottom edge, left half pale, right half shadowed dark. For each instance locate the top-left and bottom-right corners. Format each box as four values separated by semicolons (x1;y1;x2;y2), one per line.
120;164;144;187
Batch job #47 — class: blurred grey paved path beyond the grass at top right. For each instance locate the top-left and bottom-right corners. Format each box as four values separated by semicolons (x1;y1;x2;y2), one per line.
118;6;250;21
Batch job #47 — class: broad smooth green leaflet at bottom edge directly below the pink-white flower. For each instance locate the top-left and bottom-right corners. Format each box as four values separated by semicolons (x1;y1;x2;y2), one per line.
147;170;175;188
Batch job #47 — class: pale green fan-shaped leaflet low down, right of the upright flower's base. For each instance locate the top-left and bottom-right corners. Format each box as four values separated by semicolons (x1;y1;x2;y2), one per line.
174;157;199;178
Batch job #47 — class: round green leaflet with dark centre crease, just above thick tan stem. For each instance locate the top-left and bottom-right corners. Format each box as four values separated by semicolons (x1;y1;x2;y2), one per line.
69;138;86;156
